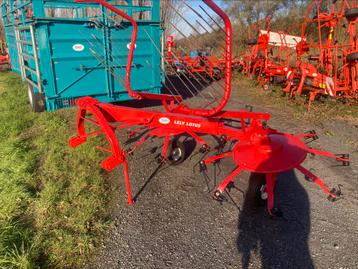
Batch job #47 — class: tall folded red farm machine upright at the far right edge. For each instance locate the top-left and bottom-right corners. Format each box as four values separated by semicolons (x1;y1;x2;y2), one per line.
285;1;358;107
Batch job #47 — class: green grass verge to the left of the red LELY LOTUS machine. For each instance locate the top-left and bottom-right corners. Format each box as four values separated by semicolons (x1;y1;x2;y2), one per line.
0;73;112;269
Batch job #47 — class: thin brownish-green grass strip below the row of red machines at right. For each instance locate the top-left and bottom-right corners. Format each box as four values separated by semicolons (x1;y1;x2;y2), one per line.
234;74;358;123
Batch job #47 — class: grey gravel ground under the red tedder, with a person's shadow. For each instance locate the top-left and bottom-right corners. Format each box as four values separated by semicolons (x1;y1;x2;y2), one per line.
85;81;358;269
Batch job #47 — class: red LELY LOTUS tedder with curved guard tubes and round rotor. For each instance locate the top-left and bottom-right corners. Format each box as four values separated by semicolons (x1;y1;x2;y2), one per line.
69;0;349;216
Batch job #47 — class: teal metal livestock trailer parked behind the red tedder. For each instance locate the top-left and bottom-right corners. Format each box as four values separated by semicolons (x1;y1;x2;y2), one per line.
1;0;163;112
